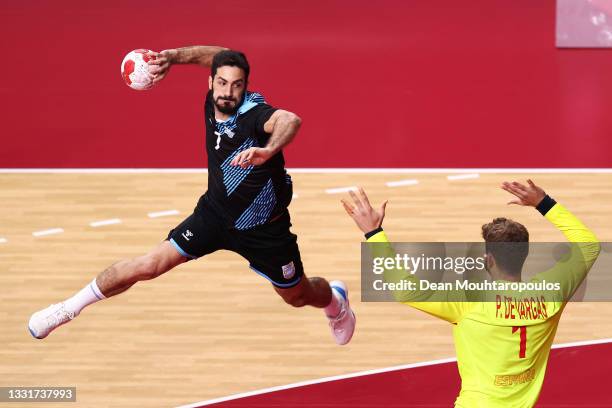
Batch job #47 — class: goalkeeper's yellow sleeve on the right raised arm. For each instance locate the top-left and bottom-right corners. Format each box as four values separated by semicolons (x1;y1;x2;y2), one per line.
532;203;601;302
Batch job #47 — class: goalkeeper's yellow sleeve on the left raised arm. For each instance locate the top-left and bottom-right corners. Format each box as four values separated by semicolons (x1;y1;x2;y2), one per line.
366;231;469;323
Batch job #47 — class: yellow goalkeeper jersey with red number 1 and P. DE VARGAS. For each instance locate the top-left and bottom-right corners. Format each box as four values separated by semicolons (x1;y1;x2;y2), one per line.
367;201;599;408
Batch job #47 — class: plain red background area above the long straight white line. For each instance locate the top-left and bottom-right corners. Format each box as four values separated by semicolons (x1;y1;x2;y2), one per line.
0;0;612;167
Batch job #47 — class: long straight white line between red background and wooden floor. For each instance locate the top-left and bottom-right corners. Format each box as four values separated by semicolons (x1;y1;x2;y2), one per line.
0;167;612;174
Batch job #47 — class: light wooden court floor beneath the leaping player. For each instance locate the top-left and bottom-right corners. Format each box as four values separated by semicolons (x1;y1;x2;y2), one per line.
0;174;612;407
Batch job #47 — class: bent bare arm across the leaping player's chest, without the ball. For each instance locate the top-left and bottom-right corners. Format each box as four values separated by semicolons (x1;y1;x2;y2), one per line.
231;109;302;168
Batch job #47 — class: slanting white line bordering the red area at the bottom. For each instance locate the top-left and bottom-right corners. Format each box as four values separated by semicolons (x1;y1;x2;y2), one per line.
177;338;612;408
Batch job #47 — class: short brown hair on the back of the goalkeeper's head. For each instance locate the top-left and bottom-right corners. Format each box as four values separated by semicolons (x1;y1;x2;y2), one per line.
482;218;529;275
